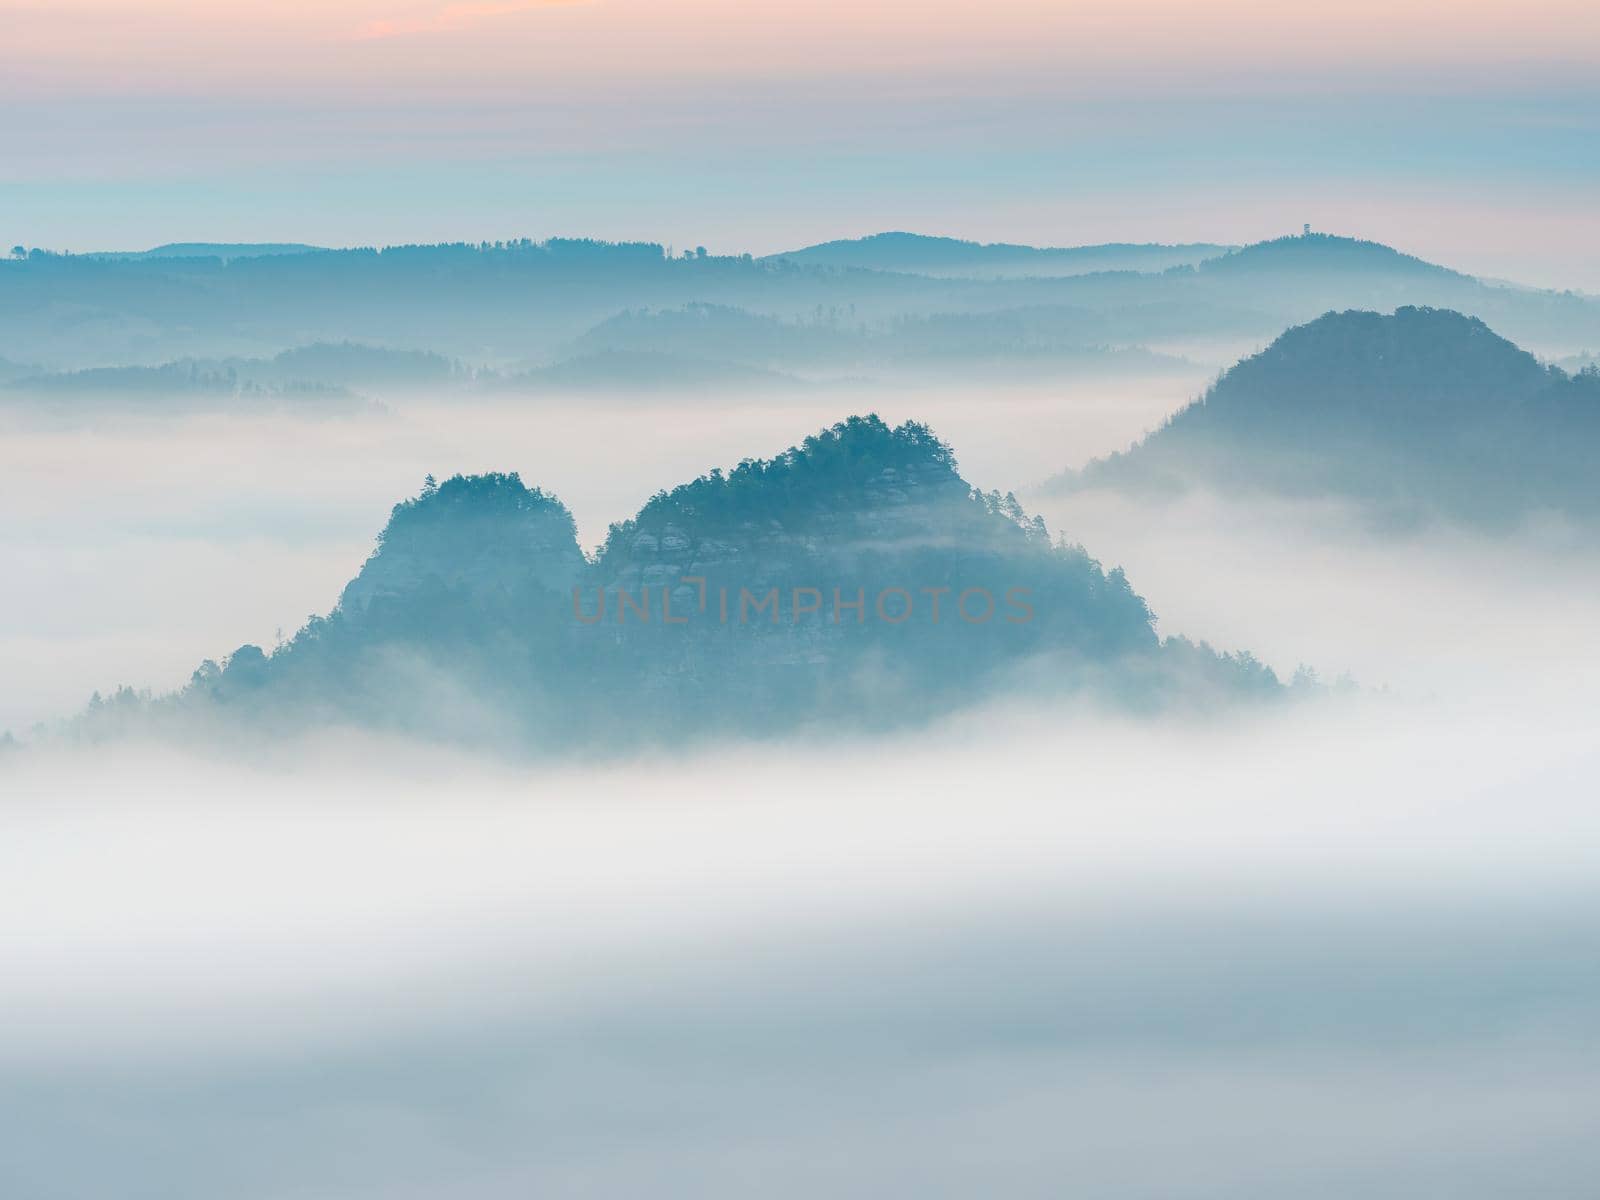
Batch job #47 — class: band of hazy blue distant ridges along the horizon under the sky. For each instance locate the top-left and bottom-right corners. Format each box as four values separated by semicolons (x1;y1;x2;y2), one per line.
12;235;1600;370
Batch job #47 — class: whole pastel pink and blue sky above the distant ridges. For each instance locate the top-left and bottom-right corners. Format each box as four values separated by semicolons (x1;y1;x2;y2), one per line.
0;0;1600;291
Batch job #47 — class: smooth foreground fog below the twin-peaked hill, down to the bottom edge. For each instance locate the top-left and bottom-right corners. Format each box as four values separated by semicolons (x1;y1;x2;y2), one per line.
0;698;1600;1197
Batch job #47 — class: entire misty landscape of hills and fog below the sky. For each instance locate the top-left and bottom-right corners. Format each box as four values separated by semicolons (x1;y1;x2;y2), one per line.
0;227;1600;1200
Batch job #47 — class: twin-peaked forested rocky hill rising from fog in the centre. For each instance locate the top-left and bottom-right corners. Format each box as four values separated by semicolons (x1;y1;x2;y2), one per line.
82;416;1278;750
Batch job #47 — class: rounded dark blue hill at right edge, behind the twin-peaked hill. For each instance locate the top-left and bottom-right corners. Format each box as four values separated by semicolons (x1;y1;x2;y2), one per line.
1062;307;1600;523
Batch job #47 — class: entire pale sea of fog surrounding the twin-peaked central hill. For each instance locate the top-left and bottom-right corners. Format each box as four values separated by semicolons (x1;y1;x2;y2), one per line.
0;381;1600;1200
